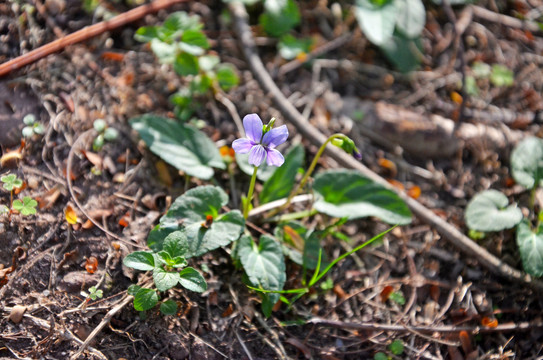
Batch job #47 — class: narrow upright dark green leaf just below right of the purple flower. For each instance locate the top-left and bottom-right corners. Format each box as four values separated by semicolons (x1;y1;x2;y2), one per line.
259;145;304;204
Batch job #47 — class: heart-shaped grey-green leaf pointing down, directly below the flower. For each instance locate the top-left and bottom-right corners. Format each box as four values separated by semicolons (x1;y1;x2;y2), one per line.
238;235;286;304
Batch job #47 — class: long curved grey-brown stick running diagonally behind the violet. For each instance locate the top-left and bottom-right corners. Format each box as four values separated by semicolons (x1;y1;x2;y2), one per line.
229;2;543;292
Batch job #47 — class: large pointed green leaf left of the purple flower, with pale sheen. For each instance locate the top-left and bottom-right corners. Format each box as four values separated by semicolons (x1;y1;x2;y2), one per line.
130;114;225;180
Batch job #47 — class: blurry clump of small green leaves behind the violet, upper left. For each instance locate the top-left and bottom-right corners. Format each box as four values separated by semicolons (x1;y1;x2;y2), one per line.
134;11;239;121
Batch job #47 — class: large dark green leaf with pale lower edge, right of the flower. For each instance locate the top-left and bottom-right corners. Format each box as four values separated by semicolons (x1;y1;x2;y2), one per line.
313;169;411;224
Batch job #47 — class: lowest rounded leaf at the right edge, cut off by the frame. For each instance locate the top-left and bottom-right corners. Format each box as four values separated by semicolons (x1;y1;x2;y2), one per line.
517;220;543;276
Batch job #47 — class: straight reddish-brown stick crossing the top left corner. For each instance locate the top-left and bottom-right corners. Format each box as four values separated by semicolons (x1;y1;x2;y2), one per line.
0;0;188;77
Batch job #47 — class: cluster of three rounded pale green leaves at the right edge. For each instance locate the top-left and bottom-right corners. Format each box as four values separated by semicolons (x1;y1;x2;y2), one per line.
464;137;543;276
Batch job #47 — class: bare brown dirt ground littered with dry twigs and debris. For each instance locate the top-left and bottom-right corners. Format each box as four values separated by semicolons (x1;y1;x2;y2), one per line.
0;0;543;359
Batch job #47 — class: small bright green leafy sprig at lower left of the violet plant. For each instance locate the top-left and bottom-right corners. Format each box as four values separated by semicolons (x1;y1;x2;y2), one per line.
123;234;207;315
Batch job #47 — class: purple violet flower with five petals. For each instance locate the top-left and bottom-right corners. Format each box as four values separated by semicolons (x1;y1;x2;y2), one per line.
232;114;288;166
